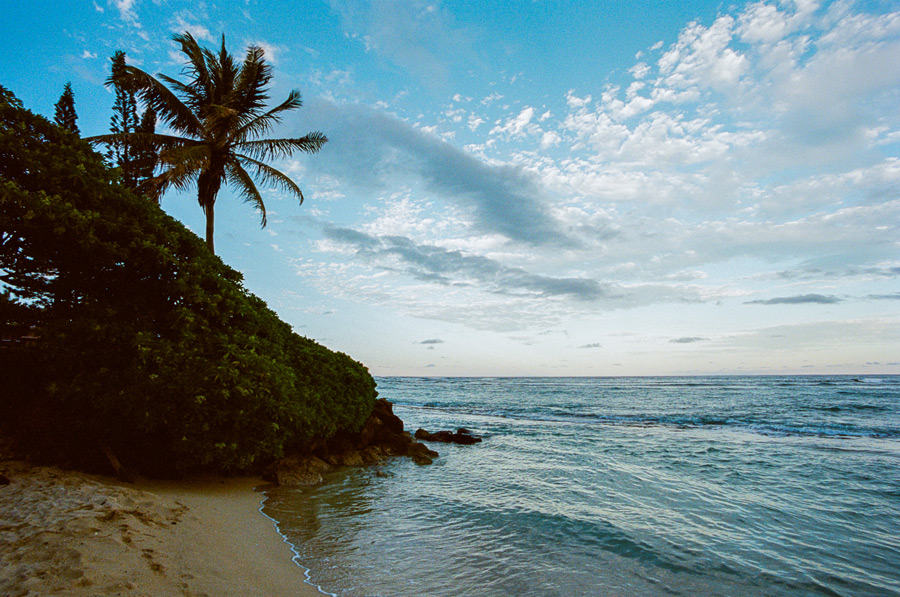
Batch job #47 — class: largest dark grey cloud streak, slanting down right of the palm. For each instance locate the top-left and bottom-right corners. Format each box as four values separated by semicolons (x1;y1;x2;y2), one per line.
303;98;578;247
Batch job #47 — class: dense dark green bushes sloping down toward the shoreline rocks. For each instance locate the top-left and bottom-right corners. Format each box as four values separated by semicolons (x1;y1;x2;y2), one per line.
0;86;376;472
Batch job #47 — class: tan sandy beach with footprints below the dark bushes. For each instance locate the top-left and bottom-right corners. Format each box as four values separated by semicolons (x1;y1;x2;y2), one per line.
0;461;321;596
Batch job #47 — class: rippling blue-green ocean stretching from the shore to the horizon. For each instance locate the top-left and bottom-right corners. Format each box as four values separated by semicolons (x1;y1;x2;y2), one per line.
263;376;900;596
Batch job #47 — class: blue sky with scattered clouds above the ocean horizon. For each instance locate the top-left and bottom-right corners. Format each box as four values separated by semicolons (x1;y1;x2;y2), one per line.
0;0;900;376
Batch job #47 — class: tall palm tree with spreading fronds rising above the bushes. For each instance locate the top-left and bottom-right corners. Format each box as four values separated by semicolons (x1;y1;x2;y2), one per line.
89;33;327;253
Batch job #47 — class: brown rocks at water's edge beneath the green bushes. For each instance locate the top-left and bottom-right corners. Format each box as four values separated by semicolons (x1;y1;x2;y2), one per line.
263;398;440;486
